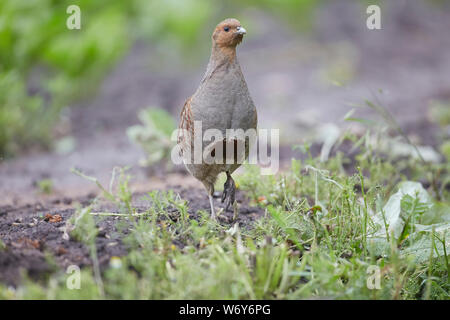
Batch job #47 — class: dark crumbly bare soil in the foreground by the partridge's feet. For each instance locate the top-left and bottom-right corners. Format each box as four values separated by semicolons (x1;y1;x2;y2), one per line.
0;186;264;285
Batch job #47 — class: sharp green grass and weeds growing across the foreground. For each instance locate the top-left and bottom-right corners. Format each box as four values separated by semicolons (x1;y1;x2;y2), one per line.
0;123;450;299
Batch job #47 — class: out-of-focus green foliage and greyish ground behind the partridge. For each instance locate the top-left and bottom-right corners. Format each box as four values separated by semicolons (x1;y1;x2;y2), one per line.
0;0;450;205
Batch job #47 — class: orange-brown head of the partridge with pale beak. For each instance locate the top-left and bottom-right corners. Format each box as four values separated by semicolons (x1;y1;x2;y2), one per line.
212;18;246;48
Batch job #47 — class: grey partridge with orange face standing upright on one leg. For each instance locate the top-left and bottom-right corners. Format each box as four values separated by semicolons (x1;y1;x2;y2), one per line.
177;18;258;219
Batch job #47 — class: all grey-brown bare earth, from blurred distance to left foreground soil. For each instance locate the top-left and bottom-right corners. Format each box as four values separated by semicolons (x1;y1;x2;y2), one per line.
0;0;450;284
